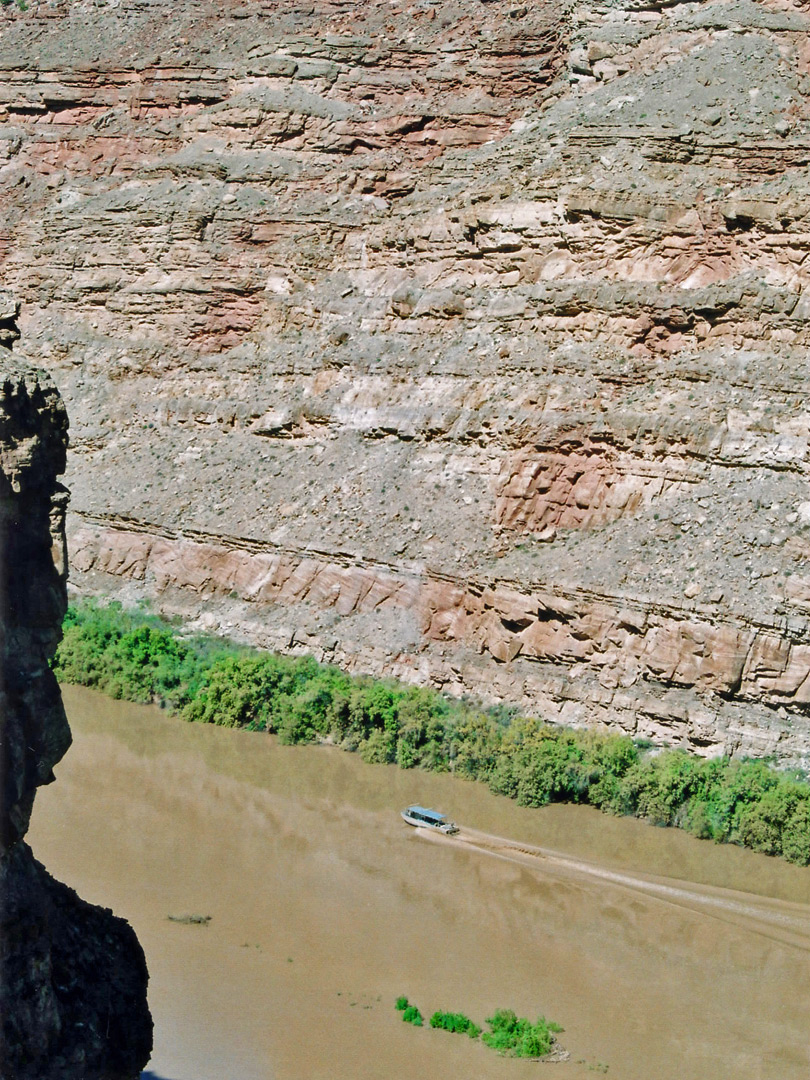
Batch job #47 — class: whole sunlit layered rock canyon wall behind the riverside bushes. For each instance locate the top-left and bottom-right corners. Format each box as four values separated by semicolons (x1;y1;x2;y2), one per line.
0;0;810;766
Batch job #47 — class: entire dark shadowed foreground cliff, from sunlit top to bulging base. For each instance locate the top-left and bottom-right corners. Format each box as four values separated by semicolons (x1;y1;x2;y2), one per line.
0;345;151;1080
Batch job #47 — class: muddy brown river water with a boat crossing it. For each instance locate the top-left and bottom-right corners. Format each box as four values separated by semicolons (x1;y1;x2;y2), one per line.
29;687;810;1080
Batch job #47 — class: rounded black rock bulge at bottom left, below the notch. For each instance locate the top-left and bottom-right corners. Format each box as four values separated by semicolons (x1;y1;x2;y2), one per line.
0;842;152;1080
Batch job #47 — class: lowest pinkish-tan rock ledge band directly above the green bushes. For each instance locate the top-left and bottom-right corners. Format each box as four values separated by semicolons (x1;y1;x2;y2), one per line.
75;518;810;766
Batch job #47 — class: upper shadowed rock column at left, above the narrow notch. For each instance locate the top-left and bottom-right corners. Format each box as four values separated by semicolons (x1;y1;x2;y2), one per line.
0;358;70;851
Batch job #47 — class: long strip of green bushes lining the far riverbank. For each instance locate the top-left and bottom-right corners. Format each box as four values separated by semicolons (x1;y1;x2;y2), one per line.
54;603;810;866
